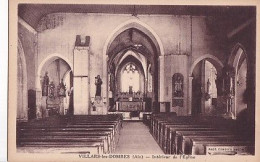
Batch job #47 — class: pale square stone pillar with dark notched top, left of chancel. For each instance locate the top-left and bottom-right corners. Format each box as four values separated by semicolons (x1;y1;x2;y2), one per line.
73;35;89;115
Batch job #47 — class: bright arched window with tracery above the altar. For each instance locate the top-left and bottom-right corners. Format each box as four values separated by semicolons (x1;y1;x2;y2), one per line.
121;63;140;92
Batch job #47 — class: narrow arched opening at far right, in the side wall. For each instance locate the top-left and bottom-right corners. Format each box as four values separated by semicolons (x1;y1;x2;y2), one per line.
228;44;248;118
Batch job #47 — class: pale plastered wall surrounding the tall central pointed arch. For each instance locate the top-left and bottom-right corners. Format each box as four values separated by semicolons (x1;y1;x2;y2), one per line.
32;13;224;115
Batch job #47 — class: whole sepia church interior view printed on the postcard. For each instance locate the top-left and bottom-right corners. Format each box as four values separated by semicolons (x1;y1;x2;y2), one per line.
16;4;256;155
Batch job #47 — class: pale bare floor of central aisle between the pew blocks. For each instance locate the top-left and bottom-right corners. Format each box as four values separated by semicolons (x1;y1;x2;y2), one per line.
115;122;164;154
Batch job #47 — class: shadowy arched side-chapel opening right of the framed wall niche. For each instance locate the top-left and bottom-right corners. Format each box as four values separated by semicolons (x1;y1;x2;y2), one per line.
190;57;225;116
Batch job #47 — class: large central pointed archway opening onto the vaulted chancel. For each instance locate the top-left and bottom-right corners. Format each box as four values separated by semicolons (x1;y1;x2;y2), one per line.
107;24;160;114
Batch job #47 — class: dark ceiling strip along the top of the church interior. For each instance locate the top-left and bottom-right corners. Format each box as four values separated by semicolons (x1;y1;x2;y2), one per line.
18;4;256;32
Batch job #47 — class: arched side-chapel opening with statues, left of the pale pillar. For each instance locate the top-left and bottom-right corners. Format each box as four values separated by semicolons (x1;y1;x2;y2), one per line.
36;56;73;118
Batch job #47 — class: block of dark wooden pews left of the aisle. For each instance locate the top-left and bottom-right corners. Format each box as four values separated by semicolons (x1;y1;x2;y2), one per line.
17;115;121;153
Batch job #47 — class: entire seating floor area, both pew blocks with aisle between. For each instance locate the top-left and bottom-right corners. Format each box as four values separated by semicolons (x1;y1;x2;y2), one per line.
17;113;254;155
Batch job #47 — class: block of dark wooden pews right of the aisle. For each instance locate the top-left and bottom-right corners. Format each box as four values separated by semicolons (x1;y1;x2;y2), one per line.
151;114;252;154
